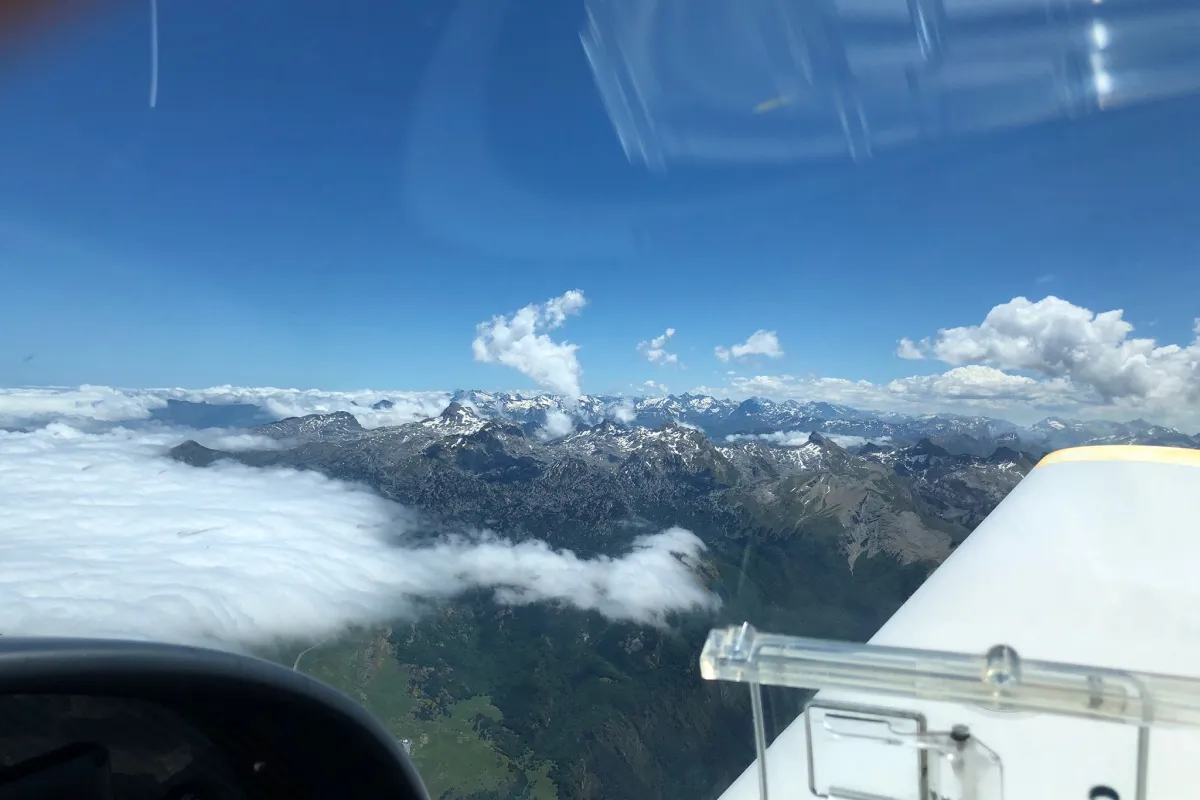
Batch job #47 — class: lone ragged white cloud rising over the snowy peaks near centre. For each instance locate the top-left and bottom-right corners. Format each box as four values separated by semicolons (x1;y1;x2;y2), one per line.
472;289;587;399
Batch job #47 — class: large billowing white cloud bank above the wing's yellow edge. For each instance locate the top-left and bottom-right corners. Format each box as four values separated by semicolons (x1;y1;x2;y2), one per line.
694;295;1200;428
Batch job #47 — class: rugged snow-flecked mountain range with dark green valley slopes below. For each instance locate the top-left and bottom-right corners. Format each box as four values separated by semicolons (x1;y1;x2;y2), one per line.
170;391;1200;800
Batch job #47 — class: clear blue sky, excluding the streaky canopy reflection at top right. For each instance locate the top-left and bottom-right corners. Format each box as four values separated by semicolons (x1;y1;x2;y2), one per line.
0;0;1200;419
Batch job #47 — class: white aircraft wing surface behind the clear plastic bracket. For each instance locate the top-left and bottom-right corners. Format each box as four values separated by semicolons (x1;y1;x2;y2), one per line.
722;449;1200;800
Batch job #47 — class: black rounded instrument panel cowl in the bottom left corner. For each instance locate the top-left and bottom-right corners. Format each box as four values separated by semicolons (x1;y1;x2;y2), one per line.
0;637;428;800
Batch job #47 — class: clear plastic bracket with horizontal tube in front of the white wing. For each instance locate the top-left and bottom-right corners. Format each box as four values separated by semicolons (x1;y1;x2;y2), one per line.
700;624;1200;800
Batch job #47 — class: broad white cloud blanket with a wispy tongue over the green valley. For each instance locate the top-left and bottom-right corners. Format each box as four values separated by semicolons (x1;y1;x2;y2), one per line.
0;422;716;648
